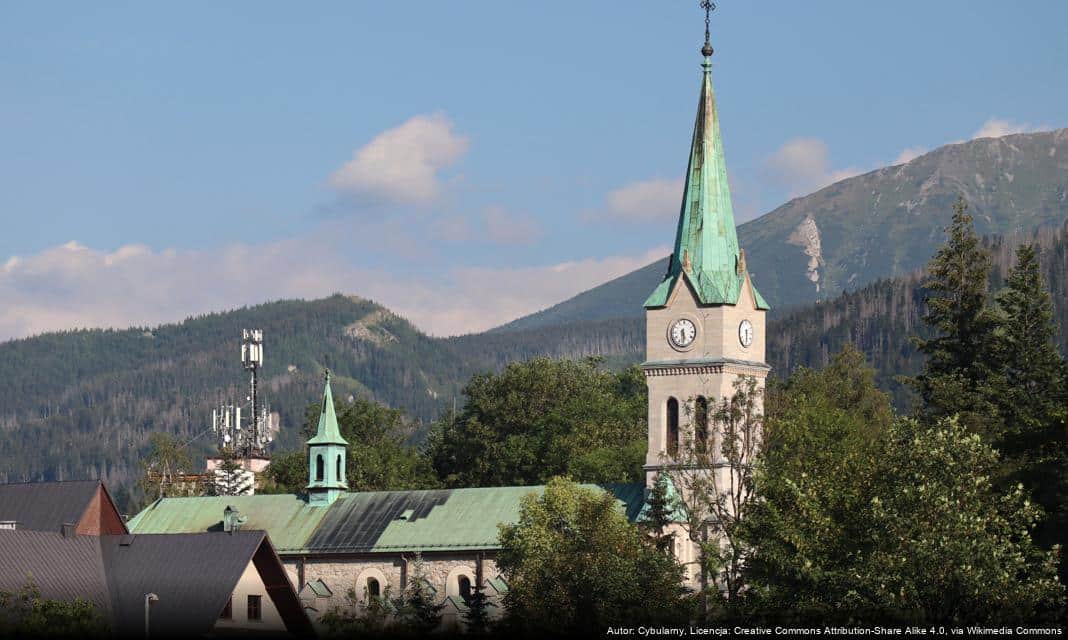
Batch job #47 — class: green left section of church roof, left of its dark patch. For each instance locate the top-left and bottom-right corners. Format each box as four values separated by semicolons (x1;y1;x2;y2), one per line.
126;494;328;553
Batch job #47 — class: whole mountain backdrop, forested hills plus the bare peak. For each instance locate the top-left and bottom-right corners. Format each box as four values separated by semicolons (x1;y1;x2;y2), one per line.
0;129;1068;491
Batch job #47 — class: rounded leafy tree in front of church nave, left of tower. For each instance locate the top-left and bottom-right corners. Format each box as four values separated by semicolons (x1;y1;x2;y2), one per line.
497;478;689;636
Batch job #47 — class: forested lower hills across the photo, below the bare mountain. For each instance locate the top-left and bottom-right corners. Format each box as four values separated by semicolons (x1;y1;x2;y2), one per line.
0;223;1068;483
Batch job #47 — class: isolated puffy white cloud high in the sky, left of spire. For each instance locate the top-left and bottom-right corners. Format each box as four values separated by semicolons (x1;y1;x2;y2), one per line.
330;113;469;204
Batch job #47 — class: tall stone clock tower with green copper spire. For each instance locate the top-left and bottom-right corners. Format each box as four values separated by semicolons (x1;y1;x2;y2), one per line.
642;20;770;487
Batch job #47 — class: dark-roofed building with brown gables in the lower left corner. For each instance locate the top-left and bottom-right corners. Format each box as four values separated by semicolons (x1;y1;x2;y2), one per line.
0;482;313;637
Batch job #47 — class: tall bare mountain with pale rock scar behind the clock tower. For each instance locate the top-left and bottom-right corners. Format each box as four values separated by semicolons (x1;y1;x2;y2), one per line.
498;129;1068;330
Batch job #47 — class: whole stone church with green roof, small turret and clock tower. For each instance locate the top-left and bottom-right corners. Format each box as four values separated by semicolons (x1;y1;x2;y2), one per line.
128;21;770;624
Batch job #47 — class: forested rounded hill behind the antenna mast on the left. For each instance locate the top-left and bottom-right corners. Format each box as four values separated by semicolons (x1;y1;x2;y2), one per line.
0;296;467;483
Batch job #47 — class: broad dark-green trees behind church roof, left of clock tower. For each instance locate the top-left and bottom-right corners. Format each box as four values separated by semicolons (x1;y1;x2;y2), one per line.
428;358;646;486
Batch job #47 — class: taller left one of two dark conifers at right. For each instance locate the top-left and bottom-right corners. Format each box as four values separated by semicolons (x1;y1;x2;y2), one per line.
913;198;1001;439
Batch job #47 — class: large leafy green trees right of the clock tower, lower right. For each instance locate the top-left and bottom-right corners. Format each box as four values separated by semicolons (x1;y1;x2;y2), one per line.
744;353;1063;622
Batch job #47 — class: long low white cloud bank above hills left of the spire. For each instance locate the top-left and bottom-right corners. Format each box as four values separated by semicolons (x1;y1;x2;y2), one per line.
0;236;669;340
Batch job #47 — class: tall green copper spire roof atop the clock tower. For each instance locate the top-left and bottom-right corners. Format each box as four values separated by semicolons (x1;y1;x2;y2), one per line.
645;48;768;309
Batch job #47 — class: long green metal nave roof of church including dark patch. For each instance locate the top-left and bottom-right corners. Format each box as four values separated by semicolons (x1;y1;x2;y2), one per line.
128;484;644;553
